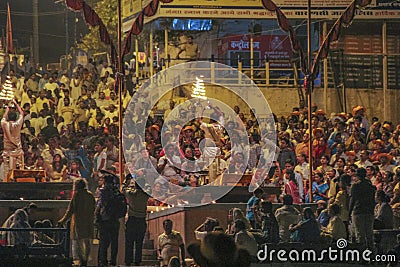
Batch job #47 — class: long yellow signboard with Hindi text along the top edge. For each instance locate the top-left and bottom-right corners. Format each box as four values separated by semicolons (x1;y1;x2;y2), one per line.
123;0;400;30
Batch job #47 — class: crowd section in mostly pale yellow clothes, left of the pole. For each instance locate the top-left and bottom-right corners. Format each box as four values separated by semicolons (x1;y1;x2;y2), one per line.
0;63;133;188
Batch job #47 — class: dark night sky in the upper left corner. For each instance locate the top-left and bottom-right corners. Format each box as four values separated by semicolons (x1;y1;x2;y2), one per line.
0;0;91;65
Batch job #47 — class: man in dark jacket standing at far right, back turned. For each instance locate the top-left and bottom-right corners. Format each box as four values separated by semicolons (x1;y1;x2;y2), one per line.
349;168;376;248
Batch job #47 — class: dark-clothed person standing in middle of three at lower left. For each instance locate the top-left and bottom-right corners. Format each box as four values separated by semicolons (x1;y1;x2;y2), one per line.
95;174;119;267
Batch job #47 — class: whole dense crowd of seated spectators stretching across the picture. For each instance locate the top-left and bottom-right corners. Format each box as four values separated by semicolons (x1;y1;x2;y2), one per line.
0;58;400;264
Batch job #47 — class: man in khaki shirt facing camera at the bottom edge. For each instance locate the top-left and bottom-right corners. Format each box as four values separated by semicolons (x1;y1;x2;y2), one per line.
158;219;186;267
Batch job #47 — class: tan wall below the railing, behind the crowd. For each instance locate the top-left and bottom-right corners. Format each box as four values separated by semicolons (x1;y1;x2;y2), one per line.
155;86;400;124
